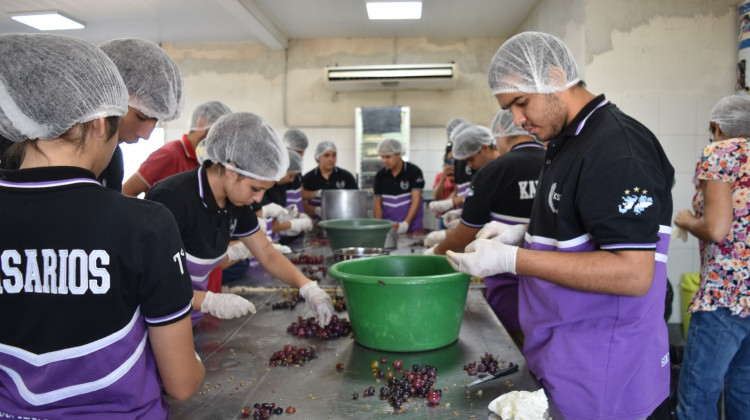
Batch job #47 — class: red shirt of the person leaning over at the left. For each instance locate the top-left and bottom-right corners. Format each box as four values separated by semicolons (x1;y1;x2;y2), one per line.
138;135;198;188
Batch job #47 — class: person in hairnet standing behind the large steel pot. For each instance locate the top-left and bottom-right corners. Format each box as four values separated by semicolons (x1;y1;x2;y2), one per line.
302;141;357;217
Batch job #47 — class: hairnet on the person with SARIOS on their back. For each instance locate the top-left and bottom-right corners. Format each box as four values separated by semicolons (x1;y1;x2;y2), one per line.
0;34;128;142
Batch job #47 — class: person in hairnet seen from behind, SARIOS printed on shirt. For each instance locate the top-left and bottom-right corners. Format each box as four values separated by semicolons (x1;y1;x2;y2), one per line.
0;34;205;419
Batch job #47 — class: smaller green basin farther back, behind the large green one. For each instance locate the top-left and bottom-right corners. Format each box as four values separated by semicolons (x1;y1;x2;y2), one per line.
318;219;394;251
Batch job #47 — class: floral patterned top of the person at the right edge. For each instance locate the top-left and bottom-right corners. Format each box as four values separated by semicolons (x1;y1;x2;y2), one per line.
688;138;750;318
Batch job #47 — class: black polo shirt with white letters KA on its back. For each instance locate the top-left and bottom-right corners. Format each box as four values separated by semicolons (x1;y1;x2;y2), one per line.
461;141;544;228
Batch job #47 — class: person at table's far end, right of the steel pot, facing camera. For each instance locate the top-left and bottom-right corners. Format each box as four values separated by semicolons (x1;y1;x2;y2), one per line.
373;139;424;233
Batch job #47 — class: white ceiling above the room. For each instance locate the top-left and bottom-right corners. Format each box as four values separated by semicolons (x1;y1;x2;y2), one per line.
0;0;538;49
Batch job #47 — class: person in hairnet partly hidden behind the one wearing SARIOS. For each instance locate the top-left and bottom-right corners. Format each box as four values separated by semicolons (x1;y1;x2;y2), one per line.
99;38;185;191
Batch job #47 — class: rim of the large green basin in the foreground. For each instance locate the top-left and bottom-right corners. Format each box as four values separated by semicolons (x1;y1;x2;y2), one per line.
328;255;471;285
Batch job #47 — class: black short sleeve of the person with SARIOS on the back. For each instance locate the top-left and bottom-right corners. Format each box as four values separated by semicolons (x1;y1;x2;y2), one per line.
138;206;193;326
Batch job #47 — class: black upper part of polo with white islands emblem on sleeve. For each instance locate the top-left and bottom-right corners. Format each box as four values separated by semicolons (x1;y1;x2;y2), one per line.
529;95;674;249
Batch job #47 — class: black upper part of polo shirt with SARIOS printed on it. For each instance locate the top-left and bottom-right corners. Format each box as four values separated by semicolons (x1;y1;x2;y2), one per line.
0;167;193;352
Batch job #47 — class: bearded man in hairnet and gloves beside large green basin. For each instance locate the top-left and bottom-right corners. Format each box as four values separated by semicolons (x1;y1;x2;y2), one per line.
446;32;674;419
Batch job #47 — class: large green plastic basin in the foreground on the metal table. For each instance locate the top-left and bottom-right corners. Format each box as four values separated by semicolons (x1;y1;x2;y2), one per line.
328;255;469;352
